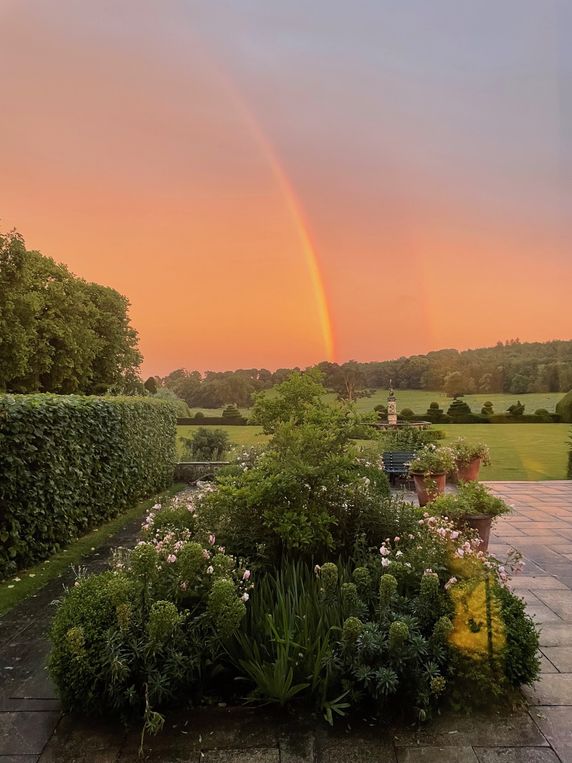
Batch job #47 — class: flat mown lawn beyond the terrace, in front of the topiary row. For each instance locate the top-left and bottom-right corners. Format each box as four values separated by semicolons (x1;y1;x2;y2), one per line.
178;424;571;480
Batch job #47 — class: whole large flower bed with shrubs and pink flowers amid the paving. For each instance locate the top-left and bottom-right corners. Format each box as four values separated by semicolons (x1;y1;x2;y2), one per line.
50;376;539;731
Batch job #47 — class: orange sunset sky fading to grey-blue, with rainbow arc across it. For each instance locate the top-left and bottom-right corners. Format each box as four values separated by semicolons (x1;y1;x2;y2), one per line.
0;0;572;375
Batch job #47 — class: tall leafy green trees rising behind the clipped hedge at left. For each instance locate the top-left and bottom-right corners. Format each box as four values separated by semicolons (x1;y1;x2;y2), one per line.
0;233;141;394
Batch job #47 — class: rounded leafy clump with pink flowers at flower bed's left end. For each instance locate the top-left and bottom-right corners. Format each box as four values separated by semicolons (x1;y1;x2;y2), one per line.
49;490;251;731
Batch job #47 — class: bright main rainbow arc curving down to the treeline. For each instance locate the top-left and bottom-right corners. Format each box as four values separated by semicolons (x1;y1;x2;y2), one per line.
201;56;336;361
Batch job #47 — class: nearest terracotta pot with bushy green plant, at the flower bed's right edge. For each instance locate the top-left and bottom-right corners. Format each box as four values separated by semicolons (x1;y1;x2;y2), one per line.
431;482;510;551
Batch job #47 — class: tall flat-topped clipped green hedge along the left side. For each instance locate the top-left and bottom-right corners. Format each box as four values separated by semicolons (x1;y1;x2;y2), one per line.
0;395;176;577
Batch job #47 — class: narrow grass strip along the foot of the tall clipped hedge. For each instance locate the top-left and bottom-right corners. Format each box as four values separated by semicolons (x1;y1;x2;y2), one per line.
0;483;185;615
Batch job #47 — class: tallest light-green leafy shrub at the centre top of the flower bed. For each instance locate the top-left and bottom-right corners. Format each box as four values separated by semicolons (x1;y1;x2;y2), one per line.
201;409;389;564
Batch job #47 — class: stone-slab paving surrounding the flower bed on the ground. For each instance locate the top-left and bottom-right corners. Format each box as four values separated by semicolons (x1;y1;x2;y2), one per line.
0;482;572;763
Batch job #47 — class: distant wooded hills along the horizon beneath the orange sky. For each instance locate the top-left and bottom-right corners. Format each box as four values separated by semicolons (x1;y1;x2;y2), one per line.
151;339;572;408
